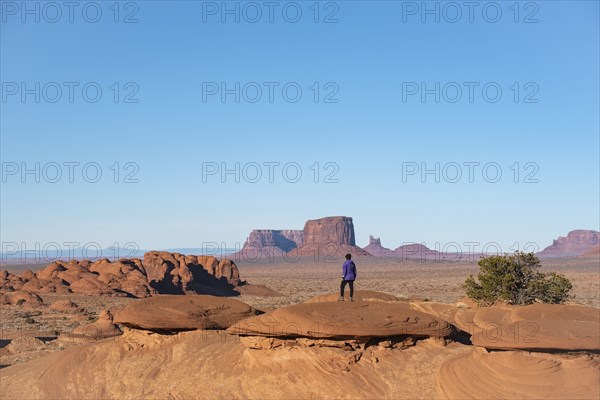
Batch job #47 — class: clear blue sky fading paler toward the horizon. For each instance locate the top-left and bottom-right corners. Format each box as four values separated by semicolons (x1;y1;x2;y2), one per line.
0;0;600;251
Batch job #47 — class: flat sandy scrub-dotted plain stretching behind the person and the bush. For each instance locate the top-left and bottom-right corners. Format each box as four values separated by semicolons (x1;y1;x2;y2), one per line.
233;257;600;309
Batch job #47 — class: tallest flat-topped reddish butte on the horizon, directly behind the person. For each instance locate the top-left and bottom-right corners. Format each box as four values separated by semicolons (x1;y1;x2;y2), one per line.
290;217;371;259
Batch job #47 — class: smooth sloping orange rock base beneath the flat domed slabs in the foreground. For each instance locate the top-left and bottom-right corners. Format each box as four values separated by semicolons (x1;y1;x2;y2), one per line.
0;331;472;399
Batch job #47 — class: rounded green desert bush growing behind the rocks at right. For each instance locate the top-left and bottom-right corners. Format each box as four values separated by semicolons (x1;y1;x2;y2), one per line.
463;251;573;305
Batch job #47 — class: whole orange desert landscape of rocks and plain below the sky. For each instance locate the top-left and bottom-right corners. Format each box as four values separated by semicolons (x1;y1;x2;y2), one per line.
0;217;600;399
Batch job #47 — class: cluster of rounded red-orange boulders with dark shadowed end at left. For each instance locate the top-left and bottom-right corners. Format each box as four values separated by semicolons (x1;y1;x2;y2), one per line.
0;251;241;296
